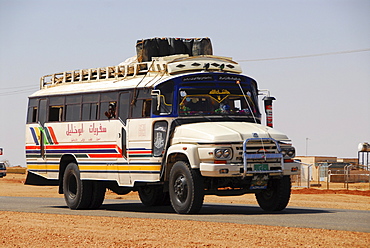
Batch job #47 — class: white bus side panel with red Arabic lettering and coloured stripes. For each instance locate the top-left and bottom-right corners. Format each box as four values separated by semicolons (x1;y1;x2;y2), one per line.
26;120;131;184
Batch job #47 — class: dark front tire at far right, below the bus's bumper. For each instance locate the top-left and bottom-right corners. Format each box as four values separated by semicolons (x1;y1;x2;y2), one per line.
256;176;292;211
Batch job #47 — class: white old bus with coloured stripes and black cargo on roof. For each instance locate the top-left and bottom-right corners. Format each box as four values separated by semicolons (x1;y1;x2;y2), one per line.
25;38;300;214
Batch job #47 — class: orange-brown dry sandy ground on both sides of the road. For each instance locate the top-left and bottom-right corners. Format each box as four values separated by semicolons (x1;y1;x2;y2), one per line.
0;174;370;247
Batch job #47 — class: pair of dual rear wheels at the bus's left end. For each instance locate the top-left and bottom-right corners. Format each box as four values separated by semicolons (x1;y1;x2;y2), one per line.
63;163;106;209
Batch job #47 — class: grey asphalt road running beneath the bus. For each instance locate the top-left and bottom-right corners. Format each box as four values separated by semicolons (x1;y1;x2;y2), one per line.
0;196;370;233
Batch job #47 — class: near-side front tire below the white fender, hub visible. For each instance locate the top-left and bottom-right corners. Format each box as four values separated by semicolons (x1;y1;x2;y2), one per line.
169;161;204;214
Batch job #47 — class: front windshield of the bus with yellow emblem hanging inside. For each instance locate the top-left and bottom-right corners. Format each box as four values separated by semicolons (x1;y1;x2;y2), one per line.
178;87;258;117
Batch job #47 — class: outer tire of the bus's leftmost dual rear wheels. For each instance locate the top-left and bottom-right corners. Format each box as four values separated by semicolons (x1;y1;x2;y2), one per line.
63;163;92;209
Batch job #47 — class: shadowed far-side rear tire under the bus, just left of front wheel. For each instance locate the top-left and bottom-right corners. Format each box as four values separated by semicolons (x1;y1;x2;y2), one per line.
138;186;171;207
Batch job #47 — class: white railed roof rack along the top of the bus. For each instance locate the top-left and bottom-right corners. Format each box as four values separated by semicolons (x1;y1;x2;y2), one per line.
40;54;242;89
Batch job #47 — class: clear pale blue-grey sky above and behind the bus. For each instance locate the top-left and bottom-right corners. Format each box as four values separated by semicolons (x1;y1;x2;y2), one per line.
0;0;370;166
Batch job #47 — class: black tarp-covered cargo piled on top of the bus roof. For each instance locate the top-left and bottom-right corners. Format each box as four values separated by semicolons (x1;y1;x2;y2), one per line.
136;38;213;62
